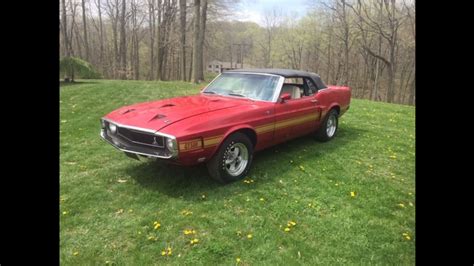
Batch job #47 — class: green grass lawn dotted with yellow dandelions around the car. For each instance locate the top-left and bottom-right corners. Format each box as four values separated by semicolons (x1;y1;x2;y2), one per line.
60;80;416;265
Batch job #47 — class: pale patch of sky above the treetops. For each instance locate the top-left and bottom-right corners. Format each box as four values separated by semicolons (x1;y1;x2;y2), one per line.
232;0;311;26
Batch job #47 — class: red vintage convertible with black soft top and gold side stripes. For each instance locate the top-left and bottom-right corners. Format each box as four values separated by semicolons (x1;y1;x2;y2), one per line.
100;69;351;183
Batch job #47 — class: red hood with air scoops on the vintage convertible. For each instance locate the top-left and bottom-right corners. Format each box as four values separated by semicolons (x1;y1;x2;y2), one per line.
105;95;251;131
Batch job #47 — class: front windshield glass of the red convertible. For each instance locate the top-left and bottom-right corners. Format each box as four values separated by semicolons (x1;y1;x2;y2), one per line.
203;73;280;101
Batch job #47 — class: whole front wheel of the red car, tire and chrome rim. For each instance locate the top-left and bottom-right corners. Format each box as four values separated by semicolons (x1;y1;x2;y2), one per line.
207;132;253;183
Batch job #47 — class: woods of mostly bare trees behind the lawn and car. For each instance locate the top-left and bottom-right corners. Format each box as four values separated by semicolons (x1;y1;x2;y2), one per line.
60;0;416;105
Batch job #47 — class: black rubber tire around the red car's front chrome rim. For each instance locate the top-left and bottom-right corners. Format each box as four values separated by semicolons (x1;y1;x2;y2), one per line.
207;132;253;183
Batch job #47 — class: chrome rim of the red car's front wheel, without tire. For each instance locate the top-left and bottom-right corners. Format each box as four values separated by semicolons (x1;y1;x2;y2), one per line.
224;143;249;176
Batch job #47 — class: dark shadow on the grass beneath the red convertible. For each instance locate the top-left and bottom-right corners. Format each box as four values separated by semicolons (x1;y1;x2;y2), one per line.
126;126;365;201
